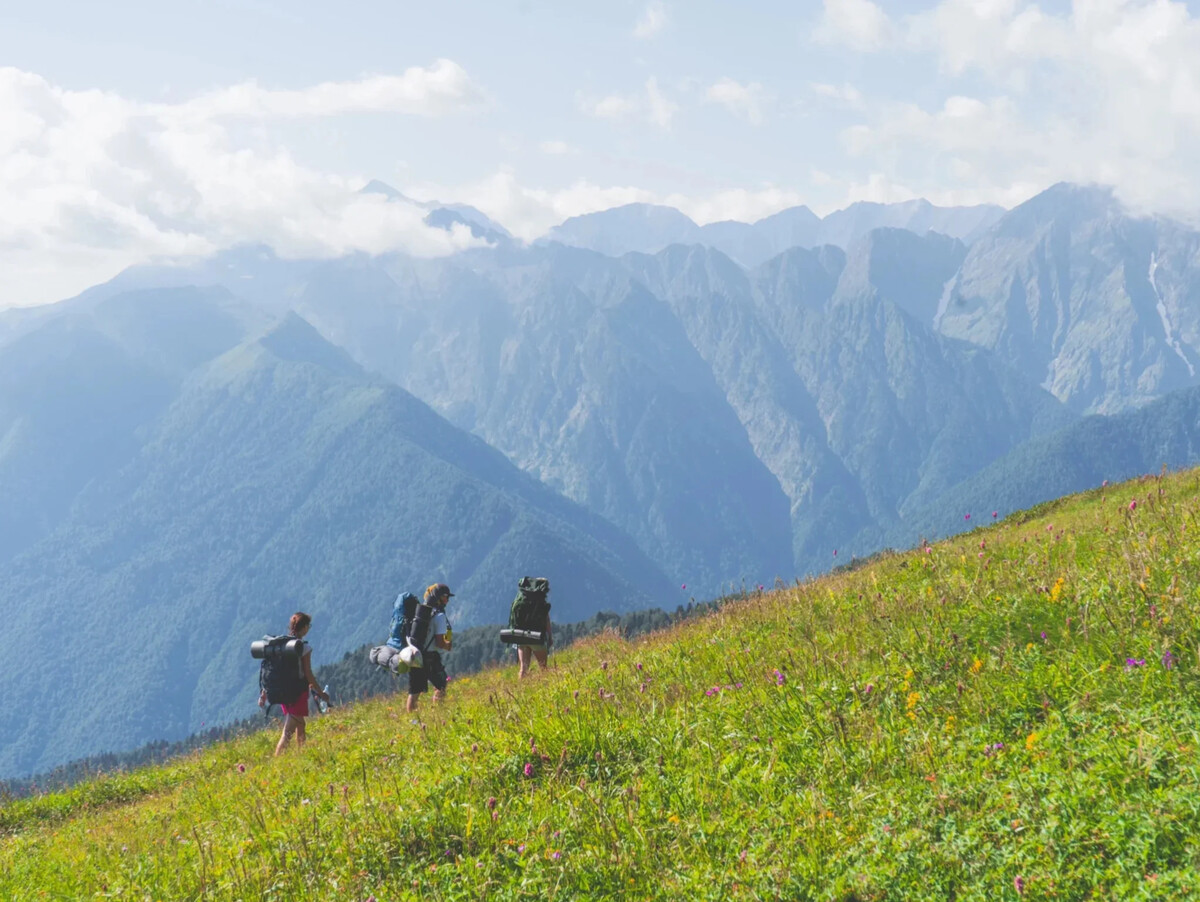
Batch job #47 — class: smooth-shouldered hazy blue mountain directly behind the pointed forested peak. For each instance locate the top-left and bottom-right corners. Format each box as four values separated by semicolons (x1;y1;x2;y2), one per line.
296;245;793;594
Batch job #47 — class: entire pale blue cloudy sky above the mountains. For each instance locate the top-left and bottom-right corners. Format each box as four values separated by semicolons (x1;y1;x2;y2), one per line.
0;0;1200;307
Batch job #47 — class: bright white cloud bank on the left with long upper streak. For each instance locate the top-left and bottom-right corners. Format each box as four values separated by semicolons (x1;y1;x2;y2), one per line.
0;61;480;306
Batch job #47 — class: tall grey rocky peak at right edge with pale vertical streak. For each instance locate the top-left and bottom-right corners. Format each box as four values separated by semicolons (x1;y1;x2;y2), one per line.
936;185;1200;413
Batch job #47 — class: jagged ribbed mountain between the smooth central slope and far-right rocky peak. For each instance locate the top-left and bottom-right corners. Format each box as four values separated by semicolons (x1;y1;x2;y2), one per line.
629;236;1069;572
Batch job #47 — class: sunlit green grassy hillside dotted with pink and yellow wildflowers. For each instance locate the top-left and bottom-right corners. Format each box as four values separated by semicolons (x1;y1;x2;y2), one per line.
0;471;1200;902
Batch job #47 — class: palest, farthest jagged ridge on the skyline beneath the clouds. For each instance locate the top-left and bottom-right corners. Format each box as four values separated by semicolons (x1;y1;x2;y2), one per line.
545;200;1004;267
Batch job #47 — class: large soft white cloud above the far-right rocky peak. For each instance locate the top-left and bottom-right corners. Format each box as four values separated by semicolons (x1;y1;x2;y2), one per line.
825;0;1200;220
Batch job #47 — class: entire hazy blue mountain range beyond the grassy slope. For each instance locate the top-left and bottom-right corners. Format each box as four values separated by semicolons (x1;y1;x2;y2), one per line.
7;184;1200;776
